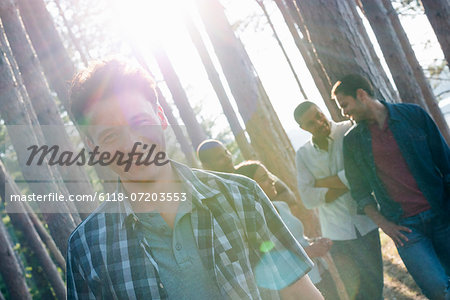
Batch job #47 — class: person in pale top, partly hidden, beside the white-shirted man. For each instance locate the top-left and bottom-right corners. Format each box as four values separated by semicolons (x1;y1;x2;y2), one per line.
236;160;339;300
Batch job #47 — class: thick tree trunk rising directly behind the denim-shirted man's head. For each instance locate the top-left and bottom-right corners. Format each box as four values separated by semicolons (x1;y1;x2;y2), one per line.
296;0;396;101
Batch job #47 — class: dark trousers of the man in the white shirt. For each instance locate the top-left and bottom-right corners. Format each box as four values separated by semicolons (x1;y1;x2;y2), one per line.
330;229;383;300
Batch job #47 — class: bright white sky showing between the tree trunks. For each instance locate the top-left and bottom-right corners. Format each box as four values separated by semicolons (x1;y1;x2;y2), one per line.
74;0;443;148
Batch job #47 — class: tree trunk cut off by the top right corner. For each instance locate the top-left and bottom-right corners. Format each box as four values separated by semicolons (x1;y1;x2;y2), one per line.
421;0;450;67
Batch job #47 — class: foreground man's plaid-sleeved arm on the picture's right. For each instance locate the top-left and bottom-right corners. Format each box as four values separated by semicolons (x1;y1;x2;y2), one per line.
245;183;322;299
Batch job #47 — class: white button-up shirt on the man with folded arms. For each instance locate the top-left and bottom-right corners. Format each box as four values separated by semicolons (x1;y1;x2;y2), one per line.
296;121;377;240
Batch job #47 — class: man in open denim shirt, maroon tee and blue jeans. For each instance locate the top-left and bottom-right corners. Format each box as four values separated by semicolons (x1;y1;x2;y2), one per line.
332;75;450;299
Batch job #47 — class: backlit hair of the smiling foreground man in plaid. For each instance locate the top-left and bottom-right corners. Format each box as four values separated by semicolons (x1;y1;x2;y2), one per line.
70;58;157;125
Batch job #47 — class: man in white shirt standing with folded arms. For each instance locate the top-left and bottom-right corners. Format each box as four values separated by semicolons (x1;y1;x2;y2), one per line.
294;101;383;300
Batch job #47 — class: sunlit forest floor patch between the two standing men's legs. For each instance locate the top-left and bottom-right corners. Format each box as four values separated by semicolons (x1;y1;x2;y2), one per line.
380;231;427;300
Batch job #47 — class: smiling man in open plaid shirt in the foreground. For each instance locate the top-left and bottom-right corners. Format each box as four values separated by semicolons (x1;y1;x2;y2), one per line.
67;60;322;299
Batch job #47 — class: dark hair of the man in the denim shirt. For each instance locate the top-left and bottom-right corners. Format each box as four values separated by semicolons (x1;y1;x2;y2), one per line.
331;74;375;98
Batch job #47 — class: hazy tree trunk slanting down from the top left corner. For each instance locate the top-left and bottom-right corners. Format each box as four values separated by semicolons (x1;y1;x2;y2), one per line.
0;0;97;218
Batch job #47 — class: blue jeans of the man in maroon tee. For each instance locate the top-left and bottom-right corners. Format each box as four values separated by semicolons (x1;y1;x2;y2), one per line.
397;210;450;300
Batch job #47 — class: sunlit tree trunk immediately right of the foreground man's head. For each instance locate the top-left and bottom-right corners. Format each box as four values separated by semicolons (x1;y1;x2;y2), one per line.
153;45;207;151
